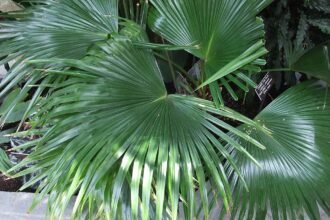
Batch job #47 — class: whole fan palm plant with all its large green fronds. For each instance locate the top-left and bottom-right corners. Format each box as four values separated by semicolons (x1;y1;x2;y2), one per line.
0;0;330;219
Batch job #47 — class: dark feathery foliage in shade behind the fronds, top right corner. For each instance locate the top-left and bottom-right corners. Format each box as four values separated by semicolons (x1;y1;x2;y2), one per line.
262;0;330;91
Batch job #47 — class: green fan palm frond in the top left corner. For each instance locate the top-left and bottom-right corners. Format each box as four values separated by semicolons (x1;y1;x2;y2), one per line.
0;0;118;123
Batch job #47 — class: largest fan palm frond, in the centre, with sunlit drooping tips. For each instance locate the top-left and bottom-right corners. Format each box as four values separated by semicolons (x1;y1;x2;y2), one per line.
5;8;263;219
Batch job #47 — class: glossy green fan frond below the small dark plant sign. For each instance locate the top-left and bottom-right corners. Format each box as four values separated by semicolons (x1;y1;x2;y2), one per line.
222;82;330;219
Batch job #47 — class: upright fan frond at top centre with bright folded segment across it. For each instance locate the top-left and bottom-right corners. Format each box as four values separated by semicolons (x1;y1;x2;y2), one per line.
149;0;271;104
